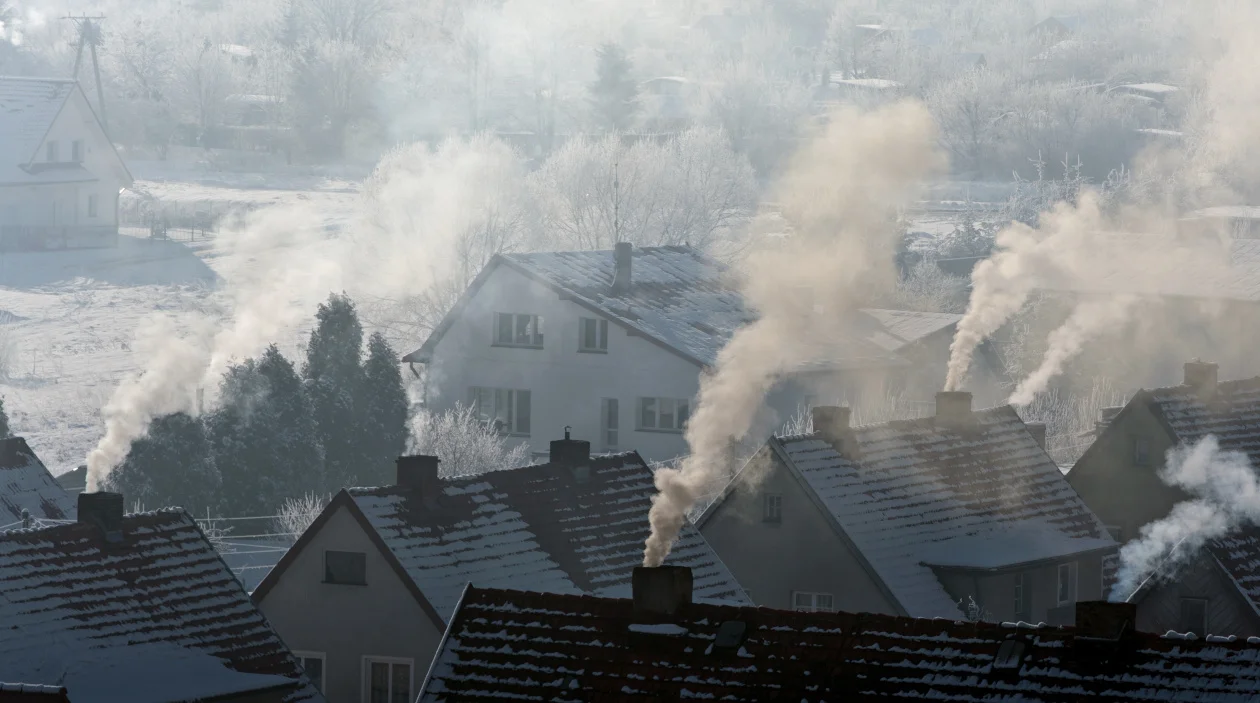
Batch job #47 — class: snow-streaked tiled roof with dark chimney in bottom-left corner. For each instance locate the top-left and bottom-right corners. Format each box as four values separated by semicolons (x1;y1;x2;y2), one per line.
0;493;324;703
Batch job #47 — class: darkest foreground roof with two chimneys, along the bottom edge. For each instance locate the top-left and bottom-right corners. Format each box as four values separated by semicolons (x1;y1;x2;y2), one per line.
418;567;1260;703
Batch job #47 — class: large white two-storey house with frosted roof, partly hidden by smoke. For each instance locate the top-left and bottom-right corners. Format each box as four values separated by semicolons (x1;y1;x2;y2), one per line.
402;243;960;461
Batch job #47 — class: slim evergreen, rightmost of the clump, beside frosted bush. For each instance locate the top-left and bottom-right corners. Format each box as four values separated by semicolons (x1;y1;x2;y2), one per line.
358;333;408;485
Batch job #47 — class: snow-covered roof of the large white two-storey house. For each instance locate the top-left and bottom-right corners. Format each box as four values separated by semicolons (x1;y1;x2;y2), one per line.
403;247;961;369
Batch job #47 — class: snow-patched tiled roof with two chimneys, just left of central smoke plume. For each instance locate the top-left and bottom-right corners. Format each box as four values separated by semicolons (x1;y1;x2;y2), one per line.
350;452;748;620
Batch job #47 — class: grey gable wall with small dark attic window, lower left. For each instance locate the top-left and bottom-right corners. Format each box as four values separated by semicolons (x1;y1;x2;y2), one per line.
258;508;442;703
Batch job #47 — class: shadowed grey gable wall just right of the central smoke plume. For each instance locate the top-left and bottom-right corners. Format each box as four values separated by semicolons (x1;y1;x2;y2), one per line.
701;450;897;615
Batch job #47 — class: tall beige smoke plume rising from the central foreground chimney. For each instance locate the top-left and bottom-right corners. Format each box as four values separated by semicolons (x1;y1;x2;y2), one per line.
644;102;945;566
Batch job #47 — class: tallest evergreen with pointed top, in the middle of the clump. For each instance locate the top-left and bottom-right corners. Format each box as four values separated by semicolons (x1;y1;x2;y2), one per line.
302;294;365;493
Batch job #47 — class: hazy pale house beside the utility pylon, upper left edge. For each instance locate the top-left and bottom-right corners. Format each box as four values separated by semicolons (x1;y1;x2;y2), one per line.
0;77;132;251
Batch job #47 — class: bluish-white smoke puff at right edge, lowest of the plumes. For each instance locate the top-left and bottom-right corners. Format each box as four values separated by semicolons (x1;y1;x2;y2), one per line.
1111;435;1260;601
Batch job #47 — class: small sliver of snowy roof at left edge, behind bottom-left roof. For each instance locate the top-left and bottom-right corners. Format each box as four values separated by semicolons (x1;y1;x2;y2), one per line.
0;437;74;532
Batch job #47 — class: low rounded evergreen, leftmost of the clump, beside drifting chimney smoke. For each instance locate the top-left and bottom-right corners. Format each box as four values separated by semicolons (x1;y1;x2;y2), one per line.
108;412;222;515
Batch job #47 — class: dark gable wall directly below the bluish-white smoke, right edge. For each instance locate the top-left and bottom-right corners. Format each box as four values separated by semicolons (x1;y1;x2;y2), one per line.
1138;557;1260;637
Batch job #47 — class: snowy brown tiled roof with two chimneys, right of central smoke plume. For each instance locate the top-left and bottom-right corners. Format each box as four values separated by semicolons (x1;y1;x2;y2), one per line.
771;407;1115;617
